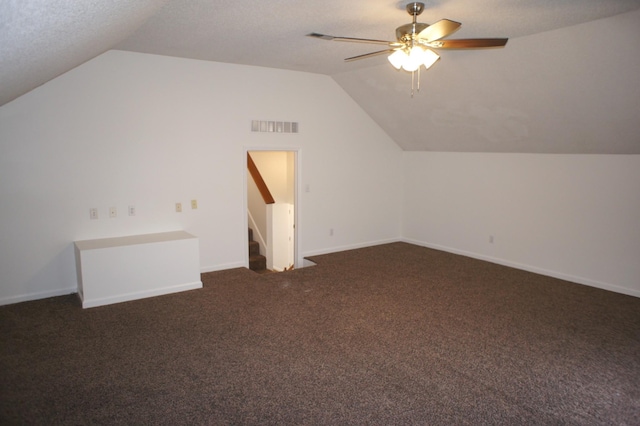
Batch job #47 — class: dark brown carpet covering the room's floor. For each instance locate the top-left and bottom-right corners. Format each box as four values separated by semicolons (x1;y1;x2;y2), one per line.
0;243;640;425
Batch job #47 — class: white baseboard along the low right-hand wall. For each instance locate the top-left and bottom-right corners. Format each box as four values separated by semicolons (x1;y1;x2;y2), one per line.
401;238;640;297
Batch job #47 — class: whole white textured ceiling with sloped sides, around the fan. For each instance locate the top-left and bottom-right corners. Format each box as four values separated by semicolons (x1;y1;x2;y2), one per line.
0;0;640;154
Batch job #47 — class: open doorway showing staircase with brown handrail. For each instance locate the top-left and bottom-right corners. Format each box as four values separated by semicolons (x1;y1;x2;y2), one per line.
245;149;297;273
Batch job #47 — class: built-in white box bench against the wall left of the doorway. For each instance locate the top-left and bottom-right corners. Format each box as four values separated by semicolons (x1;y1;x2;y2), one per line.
75;231;202;308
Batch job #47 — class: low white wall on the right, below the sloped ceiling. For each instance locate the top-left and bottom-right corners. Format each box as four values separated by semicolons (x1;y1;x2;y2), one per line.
403;152;640;296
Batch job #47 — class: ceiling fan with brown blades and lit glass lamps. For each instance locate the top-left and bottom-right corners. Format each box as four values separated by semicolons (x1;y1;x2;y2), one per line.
307;2;509;97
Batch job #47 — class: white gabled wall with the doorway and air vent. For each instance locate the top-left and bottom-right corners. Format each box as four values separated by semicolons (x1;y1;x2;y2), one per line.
0;51;401;303
